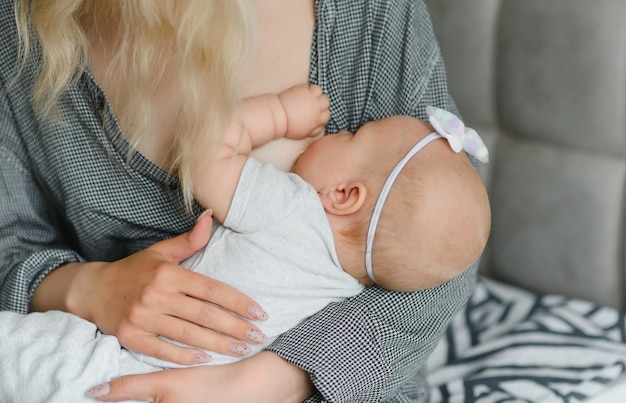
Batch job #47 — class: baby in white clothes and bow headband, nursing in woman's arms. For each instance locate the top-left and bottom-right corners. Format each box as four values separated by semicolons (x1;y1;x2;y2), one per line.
0;85;490;402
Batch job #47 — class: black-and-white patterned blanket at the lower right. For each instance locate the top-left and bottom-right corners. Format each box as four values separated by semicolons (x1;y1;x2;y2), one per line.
429;278;626;403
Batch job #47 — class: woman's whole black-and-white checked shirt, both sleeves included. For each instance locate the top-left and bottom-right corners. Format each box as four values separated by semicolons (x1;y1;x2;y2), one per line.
0;0;476;402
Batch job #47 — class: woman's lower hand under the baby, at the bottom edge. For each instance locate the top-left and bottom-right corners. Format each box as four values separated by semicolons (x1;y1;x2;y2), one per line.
87;351;313;403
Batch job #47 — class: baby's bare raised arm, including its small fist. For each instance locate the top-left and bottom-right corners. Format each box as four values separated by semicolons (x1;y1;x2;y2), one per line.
194;84;330;222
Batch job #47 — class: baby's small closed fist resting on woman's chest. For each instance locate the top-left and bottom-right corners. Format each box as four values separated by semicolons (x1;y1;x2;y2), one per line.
278;84;330;139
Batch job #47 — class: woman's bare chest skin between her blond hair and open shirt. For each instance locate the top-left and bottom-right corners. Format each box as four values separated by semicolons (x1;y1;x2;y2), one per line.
92;0;315;171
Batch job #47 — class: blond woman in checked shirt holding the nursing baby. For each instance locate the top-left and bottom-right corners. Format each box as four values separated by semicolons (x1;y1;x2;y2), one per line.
0;0;475;402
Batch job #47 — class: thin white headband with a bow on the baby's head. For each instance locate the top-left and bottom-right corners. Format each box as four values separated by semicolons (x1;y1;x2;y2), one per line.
365;106;489;282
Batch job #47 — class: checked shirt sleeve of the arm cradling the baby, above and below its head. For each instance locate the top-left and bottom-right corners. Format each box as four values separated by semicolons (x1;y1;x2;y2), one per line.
270;0;478;402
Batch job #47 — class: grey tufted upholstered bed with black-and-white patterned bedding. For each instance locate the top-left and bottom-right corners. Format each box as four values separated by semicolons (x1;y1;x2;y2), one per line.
426;0;626;403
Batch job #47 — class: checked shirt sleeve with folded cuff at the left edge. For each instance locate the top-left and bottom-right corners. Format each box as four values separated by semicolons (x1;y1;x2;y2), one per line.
0;88;82;313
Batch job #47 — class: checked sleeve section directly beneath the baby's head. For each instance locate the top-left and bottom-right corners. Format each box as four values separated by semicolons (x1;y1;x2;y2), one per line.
269;265;477;402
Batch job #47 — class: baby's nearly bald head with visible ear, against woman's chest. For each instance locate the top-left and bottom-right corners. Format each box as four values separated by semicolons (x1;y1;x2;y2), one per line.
294;112;491;291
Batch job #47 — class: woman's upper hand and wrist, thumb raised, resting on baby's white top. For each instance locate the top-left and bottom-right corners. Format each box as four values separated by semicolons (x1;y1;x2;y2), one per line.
31;214;267;365
